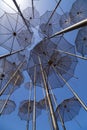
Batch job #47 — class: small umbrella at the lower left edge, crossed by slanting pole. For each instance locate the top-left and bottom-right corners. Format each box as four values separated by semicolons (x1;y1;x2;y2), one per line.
0;99;16;115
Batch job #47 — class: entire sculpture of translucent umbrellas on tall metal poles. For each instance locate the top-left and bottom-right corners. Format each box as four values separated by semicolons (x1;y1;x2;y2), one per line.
0;0;87;130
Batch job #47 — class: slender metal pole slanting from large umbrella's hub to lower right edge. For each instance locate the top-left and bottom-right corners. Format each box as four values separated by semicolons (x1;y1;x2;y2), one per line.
53;66;87;111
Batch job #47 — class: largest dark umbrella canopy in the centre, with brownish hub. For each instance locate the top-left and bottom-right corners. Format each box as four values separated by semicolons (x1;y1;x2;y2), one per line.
27;38;77;88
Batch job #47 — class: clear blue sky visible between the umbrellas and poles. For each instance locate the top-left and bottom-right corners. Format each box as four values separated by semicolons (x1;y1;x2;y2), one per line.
0;0;87;130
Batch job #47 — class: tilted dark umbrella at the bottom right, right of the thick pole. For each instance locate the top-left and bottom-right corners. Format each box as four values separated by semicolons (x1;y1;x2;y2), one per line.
55;97;81;122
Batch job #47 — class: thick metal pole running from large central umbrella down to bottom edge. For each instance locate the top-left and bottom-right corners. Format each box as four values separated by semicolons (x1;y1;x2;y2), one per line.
38;56;59;130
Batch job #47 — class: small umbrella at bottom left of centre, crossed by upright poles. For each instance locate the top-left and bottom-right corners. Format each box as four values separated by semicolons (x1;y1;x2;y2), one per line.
18;100;41;121
